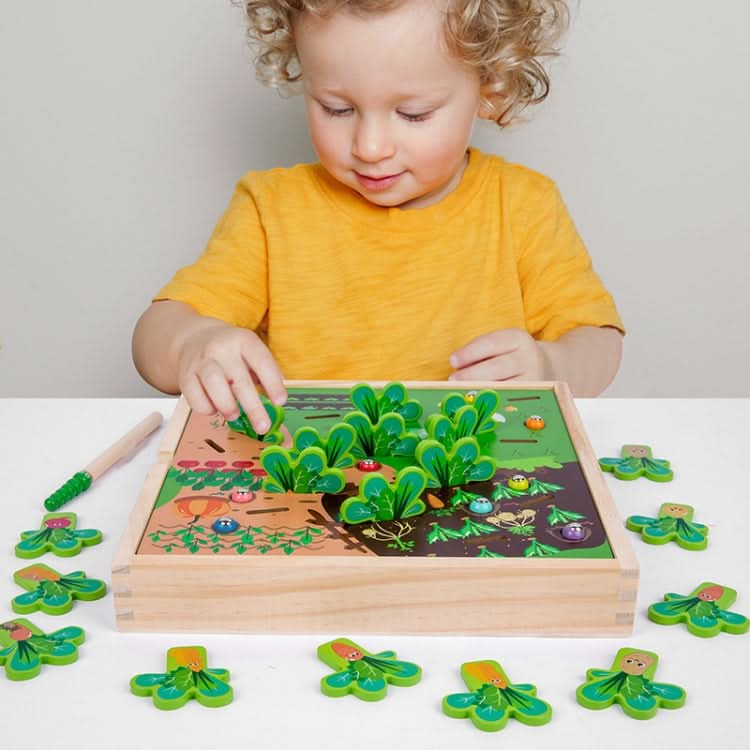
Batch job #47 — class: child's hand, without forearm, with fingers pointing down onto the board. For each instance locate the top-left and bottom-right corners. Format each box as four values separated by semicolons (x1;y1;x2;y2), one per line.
178;320;286;435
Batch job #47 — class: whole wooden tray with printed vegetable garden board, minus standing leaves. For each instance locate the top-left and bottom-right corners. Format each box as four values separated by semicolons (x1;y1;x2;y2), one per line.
112;381;638;637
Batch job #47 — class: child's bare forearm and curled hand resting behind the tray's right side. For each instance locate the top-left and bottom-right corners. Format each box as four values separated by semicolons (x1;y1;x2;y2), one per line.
450;326;622;397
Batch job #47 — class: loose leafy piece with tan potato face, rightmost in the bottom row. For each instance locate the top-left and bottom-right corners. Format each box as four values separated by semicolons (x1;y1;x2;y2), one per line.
576;647;687;719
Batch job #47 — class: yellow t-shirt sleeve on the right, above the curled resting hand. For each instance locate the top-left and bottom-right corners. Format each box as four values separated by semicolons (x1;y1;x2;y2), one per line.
518;181;625;341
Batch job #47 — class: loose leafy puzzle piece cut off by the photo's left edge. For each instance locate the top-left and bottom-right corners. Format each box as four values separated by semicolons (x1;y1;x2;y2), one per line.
0;617;86;680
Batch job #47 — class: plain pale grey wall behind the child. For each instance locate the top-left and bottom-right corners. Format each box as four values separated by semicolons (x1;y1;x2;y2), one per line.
0;0;750;397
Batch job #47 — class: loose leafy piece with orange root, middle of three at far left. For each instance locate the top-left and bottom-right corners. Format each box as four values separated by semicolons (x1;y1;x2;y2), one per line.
10;563;107;615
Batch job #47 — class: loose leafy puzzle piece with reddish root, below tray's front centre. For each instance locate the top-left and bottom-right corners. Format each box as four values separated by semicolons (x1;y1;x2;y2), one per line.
318;638;422;701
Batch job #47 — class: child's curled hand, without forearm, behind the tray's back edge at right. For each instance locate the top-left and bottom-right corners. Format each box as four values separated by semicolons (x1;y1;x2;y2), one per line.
449;328;551;380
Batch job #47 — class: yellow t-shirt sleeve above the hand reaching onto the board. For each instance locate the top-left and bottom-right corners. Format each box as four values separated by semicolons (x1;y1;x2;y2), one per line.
154;180;268;330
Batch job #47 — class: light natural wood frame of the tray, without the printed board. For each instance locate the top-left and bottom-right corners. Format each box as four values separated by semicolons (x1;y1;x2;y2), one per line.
112;381;639;637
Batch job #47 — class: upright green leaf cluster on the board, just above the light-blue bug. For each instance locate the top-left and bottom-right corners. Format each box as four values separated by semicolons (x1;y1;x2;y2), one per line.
415;437;495;487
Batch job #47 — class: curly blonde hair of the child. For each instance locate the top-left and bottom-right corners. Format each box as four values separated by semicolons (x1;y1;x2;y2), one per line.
243;0;568;127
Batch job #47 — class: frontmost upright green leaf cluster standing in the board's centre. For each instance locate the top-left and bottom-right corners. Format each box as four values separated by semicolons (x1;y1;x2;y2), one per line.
340;466;427;523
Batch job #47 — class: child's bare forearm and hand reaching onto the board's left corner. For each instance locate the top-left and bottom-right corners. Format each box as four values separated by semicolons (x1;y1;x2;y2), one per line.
133;300;286;434
